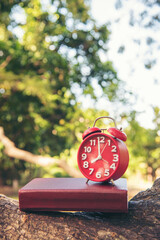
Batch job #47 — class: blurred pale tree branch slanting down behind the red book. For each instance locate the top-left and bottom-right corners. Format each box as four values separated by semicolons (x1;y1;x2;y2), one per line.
0;127;82;177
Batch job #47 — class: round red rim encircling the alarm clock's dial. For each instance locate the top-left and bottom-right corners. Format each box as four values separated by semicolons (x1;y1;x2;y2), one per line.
77;132;120;182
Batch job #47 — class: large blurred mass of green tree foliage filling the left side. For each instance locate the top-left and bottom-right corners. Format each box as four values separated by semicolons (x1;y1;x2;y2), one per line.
0;0;119;185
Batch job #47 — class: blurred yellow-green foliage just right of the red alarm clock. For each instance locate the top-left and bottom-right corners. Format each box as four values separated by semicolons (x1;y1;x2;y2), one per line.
126;107;160;179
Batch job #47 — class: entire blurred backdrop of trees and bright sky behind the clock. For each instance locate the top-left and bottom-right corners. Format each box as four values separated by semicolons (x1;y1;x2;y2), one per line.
0;0;160;198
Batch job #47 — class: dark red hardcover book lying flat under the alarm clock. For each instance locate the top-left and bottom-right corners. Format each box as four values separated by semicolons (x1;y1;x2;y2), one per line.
19;178;128;212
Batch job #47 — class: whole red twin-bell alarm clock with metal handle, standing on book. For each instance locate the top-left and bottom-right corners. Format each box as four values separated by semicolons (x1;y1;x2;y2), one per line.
77;117;129;182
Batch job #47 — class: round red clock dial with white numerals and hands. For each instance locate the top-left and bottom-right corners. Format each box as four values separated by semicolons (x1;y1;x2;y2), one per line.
78;133;119;182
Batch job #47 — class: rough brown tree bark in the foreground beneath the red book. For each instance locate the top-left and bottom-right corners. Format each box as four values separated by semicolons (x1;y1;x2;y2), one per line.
0;178;160;240
